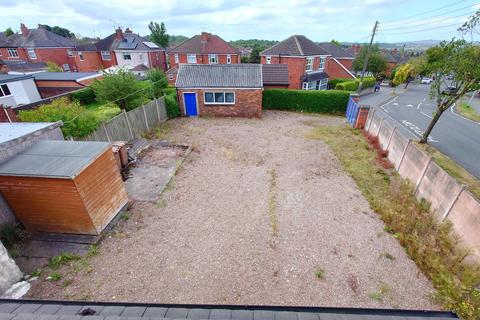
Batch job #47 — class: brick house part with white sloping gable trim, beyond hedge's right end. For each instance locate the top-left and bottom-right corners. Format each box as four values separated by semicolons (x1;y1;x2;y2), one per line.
318;42;356;79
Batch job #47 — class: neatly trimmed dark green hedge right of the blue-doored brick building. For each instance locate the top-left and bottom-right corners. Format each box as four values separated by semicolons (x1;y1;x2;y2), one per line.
262;89;350;114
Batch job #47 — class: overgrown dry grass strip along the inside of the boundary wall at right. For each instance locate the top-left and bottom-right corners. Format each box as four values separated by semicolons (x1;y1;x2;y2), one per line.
308;126;480;320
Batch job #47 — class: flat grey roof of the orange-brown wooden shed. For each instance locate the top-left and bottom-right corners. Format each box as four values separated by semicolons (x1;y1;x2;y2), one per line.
0;140;109;179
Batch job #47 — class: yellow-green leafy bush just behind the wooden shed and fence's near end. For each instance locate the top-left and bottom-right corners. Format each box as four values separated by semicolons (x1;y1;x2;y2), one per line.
19;98;98;137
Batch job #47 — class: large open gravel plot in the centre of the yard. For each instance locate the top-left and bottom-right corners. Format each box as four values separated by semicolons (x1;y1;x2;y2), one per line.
30;112;438;309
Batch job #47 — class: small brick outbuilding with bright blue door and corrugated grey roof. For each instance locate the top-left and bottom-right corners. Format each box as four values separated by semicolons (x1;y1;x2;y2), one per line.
175;64;263;118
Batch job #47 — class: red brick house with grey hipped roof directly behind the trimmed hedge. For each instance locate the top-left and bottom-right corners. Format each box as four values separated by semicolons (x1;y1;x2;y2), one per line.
260;35;329;90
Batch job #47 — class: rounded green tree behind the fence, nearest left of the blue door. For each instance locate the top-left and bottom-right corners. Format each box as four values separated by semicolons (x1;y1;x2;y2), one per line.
91;70;147;110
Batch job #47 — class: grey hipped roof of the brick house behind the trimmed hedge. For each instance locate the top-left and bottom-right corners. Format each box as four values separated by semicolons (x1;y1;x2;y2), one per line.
260;35;328;56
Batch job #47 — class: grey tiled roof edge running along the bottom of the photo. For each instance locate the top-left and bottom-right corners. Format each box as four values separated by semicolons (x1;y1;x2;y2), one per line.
0;300;458;320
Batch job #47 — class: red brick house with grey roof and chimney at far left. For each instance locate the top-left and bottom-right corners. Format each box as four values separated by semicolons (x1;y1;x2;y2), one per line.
0;23;76;71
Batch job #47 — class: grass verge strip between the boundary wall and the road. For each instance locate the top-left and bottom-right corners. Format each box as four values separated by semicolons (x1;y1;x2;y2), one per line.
417;143;480;198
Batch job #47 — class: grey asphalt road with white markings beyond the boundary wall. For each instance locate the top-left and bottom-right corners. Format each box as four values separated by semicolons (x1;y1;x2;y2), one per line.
360;84;480;178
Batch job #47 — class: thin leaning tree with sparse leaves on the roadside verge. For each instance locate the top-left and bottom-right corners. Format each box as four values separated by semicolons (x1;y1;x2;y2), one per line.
420;39;480;143
